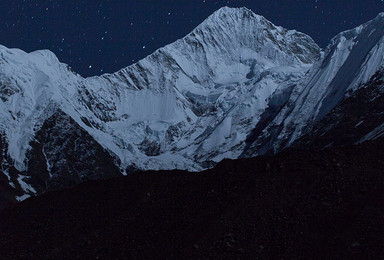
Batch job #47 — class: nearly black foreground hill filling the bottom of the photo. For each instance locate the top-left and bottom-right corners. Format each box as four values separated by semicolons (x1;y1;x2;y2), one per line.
0;140;384;259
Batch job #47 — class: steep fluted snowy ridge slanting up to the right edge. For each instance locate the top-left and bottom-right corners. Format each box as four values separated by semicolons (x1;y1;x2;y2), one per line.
243;13;384;156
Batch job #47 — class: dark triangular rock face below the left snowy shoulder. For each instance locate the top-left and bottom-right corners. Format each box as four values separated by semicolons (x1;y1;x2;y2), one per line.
27;112;122;192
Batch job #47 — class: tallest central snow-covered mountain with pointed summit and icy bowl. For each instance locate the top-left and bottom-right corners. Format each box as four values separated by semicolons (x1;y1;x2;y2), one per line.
76;8;319;171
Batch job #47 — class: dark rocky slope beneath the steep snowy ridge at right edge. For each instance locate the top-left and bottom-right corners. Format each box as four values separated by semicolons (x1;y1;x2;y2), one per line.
294;69;384;149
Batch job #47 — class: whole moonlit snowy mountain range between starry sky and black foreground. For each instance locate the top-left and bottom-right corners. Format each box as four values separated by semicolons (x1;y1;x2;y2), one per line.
0;7;384;206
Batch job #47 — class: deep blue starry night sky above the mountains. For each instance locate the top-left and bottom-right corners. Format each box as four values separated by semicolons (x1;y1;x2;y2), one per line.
0;0;384;76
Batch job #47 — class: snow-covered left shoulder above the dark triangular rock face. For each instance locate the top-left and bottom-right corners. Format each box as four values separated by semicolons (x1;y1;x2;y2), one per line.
0;46;81;170
